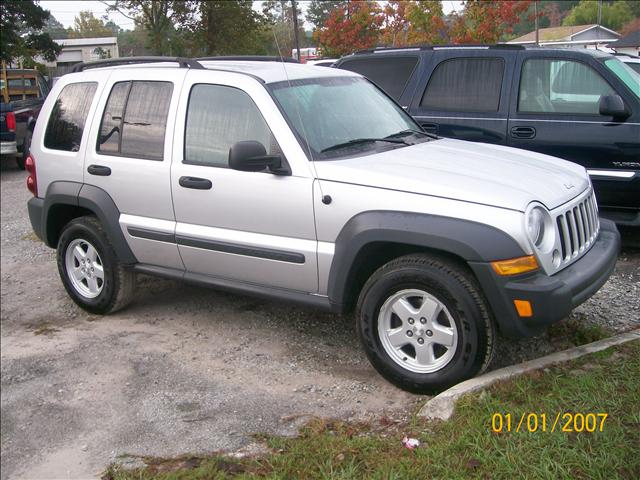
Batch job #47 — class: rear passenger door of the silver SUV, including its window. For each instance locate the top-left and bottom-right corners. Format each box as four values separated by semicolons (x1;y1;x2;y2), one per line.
84;68;186;270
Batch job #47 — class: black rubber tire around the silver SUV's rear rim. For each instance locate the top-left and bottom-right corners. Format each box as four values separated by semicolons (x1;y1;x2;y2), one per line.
57;216;136;314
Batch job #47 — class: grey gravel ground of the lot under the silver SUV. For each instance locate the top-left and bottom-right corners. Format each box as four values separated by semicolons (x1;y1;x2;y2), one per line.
0;159;640;480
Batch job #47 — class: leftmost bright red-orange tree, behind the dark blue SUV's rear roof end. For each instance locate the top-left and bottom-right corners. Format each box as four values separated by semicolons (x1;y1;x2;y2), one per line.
315;0;383;57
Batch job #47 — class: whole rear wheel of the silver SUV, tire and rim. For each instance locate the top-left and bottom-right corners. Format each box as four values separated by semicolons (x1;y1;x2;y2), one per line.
57;217;136;314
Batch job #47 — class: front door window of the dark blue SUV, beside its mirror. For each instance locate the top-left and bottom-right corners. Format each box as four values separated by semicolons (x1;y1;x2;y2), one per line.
518;58;615;115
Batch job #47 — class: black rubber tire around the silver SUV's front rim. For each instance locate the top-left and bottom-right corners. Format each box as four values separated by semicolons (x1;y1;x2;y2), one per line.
356;254;496;394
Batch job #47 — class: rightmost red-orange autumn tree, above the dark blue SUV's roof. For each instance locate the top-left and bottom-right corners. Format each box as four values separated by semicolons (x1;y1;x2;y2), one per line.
451;0;532;44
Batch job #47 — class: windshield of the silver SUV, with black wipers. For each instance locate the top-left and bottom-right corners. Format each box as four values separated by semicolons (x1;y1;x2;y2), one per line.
268;77;429;160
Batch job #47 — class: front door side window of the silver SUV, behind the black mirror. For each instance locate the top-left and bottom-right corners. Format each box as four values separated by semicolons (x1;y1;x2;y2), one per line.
184;85;279;167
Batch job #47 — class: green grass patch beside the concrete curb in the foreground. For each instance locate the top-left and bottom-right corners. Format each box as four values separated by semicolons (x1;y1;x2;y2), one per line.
103;341;640;480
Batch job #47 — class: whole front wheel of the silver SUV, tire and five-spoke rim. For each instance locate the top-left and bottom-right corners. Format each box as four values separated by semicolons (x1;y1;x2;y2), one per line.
357;255;495;393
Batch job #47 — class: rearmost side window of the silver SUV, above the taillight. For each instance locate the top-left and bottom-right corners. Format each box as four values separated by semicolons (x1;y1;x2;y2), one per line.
44;82;98;152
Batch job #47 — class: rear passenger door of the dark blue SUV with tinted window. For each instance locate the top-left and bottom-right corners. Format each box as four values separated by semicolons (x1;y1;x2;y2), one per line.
409;48;513;144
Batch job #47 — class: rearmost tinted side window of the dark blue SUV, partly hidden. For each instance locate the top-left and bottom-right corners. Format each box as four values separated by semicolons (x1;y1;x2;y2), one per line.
340;57;418;101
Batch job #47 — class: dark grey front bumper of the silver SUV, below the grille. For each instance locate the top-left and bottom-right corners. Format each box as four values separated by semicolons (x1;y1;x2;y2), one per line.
469;219;620;337
